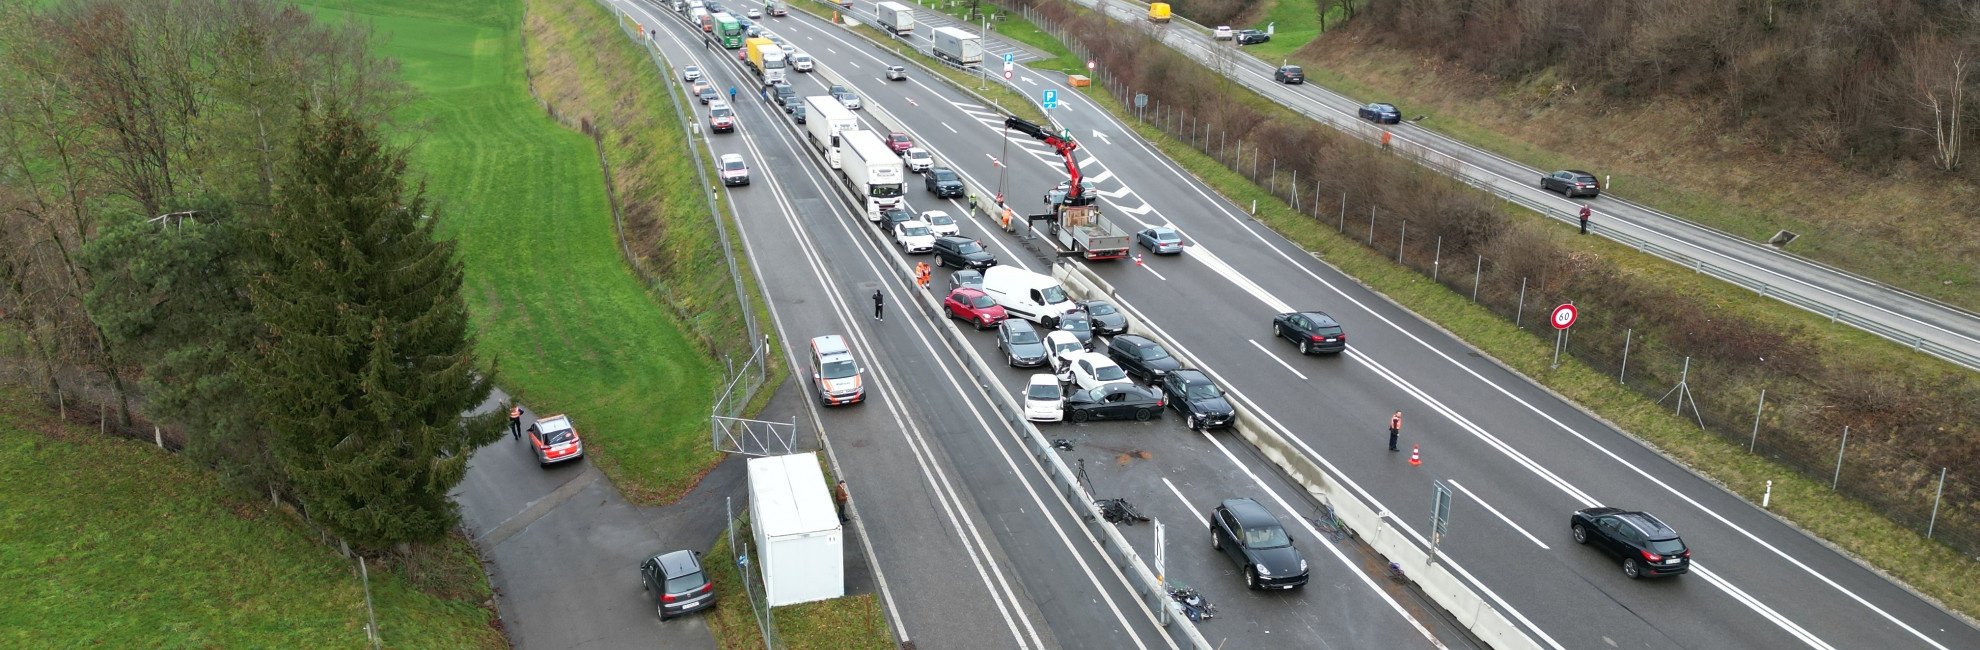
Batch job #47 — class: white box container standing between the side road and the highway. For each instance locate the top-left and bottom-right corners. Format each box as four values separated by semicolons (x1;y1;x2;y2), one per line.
748;452;845;606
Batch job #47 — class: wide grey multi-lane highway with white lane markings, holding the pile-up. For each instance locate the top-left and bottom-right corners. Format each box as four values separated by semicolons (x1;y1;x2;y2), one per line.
601;4;1980;648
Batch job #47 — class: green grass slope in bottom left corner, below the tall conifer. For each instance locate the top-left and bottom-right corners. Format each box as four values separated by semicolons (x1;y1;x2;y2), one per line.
0;386;507;648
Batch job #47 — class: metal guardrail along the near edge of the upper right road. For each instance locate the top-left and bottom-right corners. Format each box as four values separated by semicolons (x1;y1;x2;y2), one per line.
1071;0;1980;371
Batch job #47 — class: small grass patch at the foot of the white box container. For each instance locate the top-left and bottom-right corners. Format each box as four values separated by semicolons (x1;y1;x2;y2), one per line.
701;527;893;650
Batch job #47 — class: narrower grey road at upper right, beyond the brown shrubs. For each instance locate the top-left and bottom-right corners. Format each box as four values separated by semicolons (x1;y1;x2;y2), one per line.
1073;0;1980;371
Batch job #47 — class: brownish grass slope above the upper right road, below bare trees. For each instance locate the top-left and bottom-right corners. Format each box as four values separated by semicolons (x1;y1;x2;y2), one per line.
1293;28;1980;309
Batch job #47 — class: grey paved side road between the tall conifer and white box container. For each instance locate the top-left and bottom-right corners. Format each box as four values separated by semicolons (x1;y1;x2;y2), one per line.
453;382;873;648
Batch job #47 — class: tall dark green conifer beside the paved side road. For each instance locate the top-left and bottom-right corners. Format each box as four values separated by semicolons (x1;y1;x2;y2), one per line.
249;109;501;549
